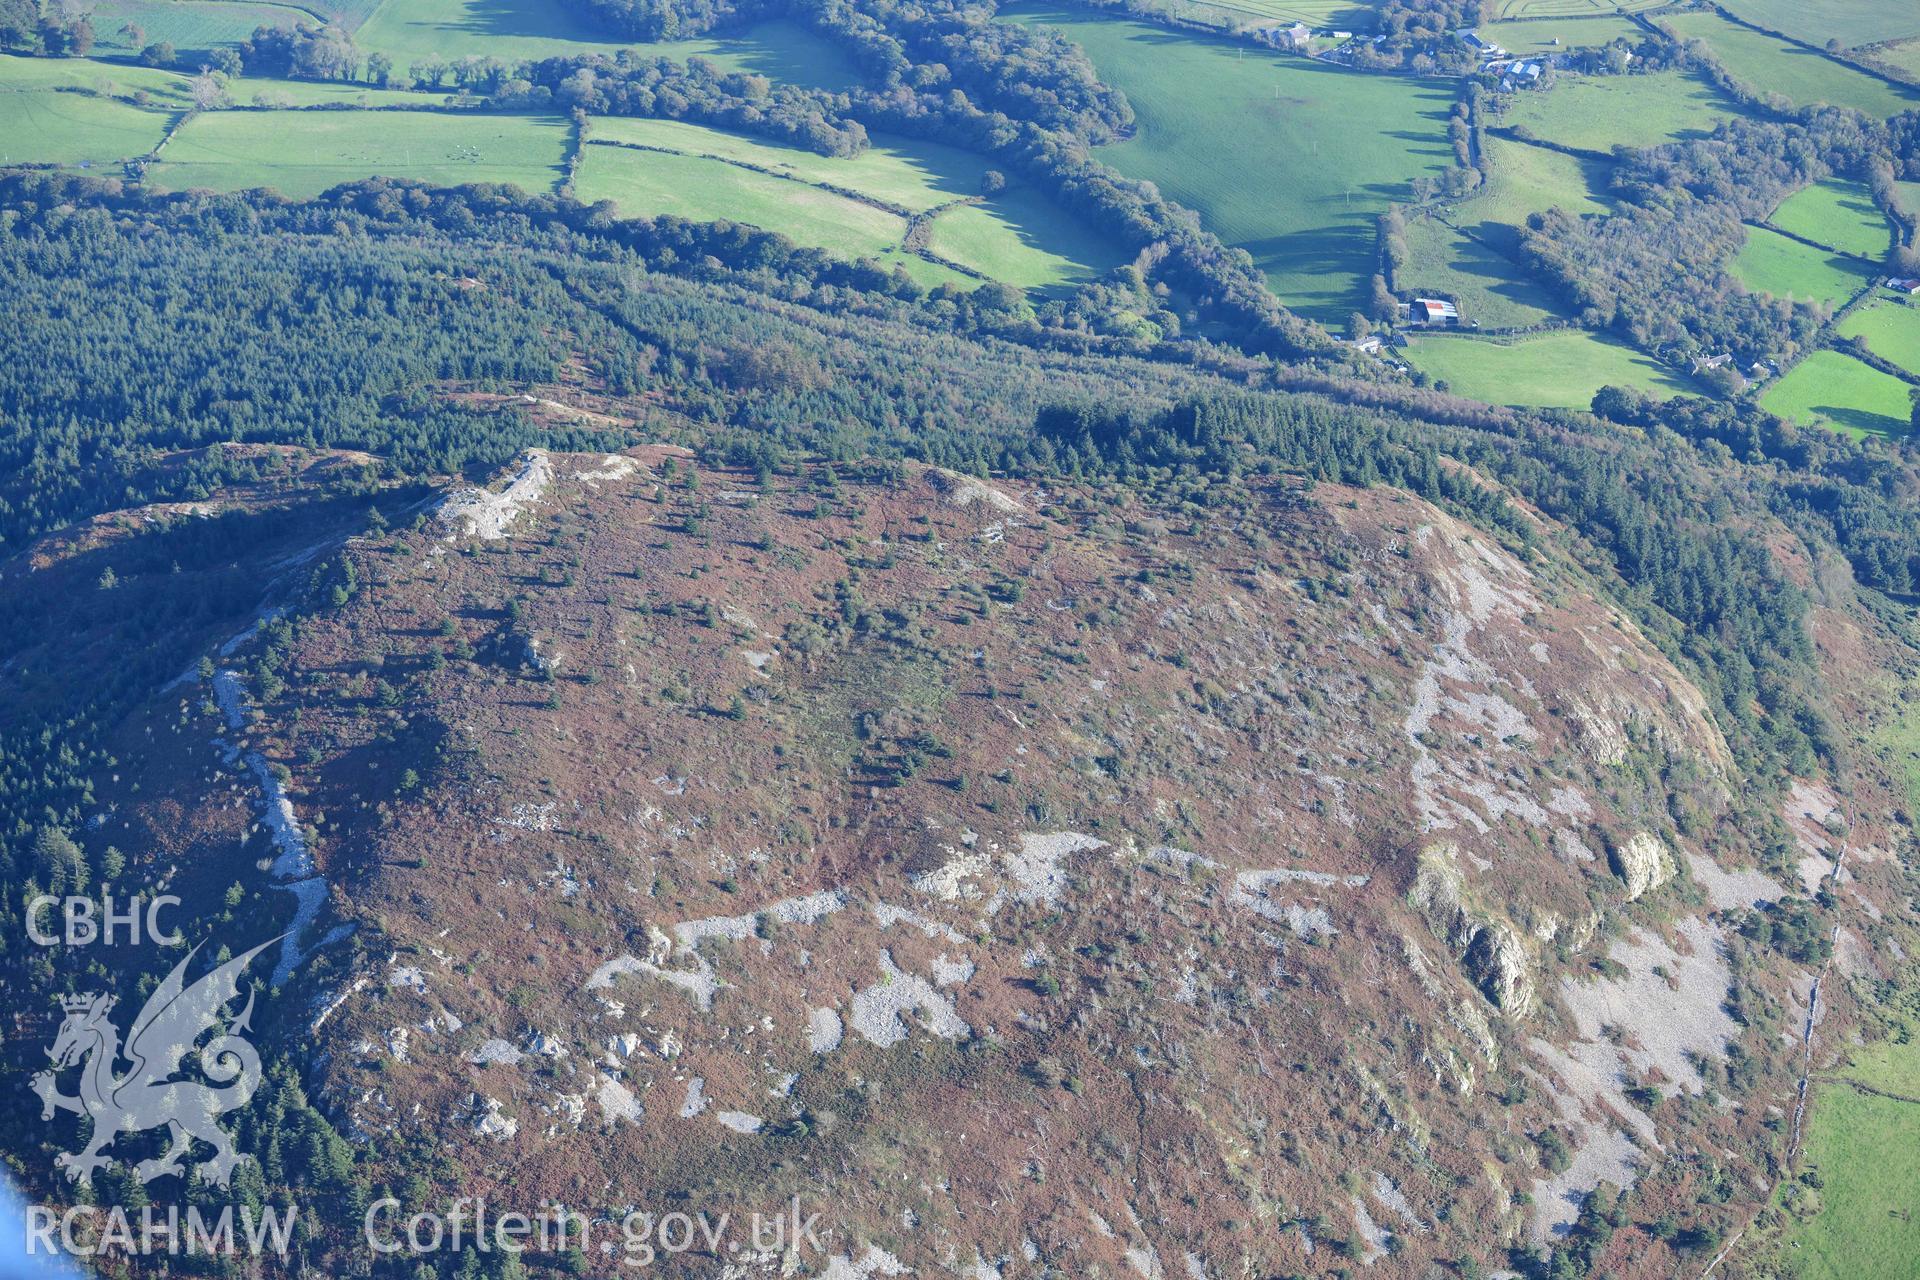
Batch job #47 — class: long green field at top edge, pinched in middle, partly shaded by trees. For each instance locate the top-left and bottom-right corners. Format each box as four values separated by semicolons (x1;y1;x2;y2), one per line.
353;0;858;88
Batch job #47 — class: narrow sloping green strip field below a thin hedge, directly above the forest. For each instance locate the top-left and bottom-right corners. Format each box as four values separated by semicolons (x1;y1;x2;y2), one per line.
574;146;973;288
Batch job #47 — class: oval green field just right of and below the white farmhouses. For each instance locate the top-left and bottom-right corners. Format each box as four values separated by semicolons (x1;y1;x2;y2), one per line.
1500;71;1743;154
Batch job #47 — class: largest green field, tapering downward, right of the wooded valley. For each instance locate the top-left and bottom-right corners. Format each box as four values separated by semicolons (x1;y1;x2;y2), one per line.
1008;6;1453;320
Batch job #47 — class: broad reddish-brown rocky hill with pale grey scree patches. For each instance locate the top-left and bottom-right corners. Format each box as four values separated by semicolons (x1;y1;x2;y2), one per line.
15;447;1896;1276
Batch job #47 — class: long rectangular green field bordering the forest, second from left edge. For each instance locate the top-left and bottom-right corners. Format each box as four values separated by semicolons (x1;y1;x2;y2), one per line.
148;111;566;198
